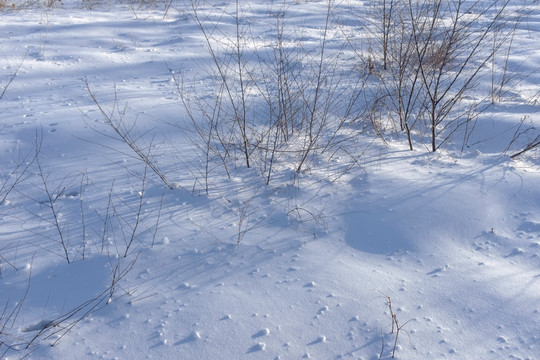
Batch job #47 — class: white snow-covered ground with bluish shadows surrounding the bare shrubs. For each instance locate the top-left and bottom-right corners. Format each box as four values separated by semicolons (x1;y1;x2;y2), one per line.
0;0;540;359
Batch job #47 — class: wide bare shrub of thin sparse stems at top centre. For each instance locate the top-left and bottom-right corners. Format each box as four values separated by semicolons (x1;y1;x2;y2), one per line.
176;0;365;191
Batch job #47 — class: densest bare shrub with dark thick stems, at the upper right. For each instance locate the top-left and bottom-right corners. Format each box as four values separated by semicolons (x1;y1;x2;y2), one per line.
368;0;526;151
